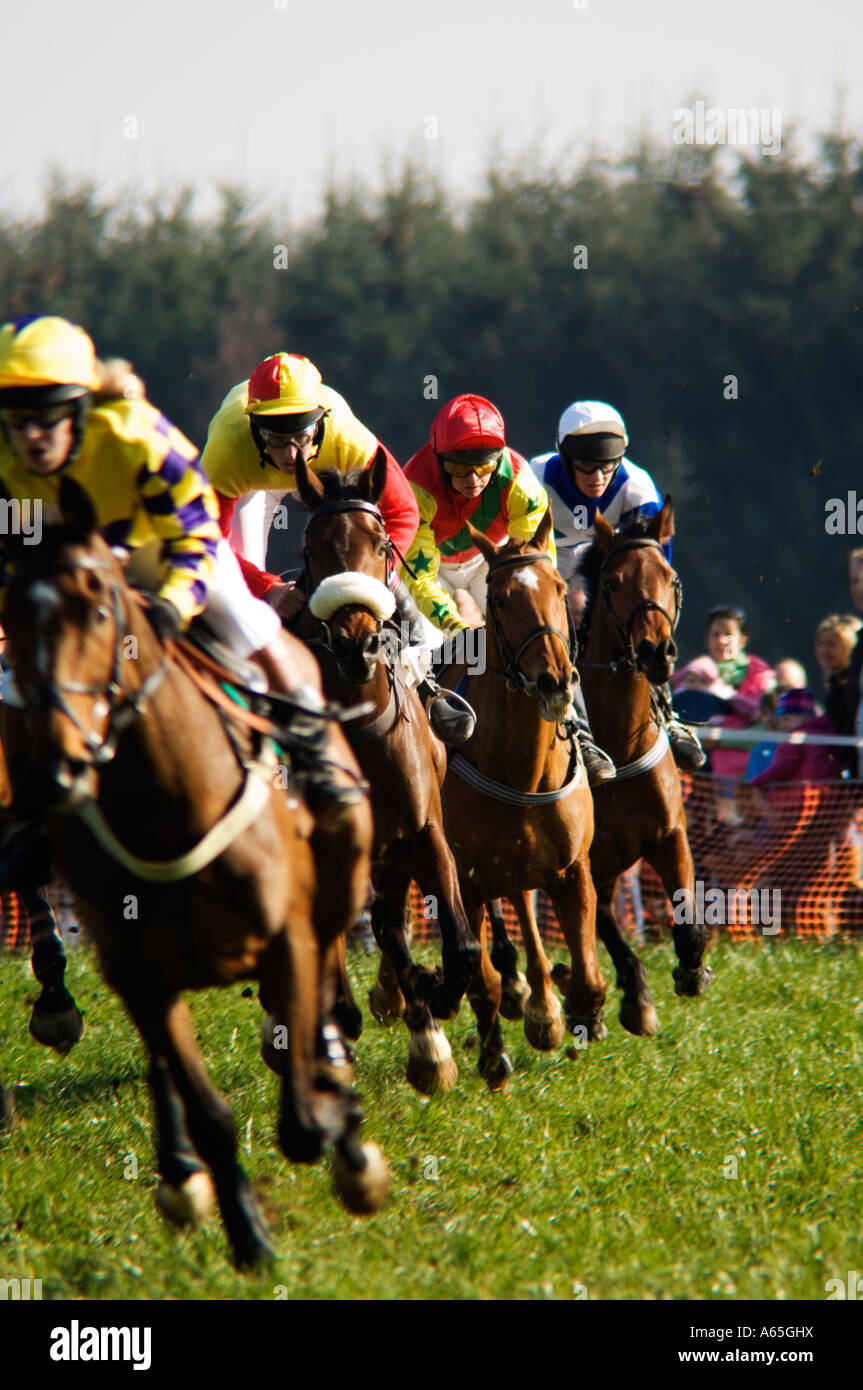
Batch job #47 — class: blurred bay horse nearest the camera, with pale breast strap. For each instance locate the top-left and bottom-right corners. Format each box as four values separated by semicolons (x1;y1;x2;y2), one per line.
4;478;386;1266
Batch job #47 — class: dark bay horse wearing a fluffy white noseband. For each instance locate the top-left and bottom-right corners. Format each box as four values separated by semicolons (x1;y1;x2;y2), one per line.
295;459;479;1093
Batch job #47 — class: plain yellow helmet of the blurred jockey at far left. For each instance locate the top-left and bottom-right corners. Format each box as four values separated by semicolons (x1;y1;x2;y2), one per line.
0;314;99;402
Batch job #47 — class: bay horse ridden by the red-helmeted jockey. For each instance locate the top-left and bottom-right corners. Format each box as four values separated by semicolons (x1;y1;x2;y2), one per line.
443;512;606;1088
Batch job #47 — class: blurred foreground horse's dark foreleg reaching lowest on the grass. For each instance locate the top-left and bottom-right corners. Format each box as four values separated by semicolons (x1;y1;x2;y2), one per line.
128;981;274;1268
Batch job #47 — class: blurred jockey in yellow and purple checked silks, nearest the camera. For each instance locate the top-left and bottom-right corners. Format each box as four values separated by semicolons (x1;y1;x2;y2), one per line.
0;316;360;883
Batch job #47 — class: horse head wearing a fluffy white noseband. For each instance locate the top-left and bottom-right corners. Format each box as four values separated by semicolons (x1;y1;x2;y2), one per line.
296;452;395;685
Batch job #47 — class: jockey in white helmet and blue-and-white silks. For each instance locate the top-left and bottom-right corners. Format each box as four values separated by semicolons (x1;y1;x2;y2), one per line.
531;400;706;771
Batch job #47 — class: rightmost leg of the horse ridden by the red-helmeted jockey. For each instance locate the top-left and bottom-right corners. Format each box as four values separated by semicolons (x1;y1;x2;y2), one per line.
548;855;607;1041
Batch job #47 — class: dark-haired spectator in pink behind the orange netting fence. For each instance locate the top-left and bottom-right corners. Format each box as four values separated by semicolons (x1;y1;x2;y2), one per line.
671;607;775;777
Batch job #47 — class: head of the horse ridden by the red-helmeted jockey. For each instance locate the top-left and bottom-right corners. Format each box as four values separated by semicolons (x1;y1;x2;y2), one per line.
468;512;574;723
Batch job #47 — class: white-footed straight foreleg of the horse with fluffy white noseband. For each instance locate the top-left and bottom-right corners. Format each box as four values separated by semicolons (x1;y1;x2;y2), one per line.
371;863;459;1095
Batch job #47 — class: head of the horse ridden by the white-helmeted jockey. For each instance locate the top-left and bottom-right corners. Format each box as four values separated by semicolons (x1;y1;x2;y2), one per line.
593;496;681;685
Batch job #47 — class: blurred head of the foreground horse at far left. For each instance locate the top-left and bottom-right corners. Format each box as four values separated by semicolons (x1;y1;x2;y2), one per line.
4;478;156;810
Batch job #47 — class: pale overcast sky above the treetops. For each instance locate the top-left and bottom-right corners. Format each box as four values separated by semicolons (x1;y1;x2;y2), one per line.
0;0;863;217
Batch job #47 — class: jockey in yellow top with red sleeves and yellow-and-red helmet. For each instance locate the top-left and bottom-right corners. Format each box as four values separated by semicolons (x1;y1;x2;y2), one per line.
202;352;472;742
